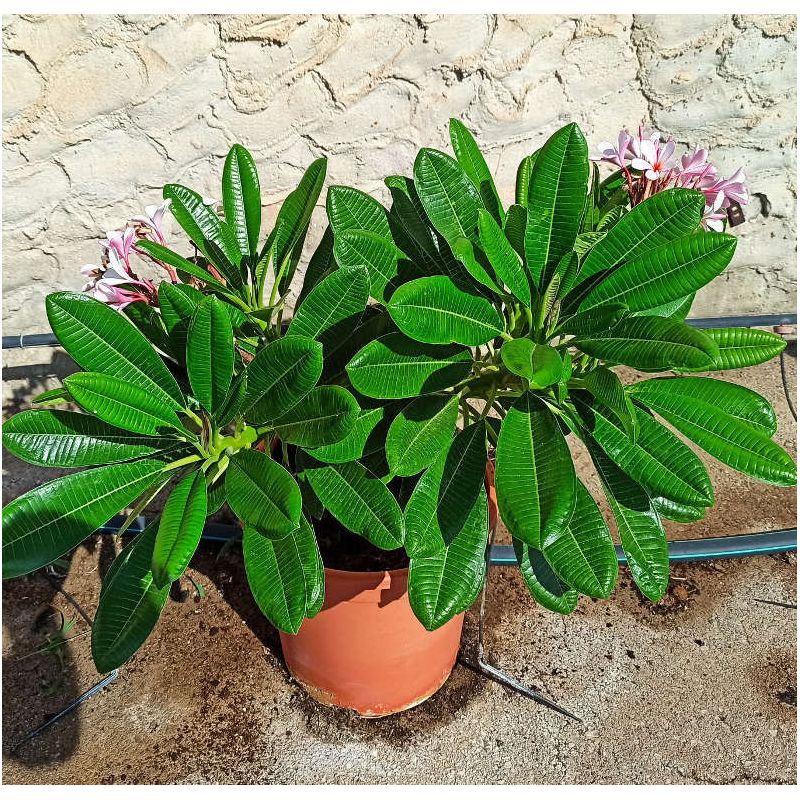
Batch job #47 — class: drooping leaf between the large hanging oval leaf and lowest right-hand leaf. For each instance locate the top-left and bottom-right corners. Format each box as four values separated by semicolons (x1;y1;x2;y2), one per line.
542;480;617;597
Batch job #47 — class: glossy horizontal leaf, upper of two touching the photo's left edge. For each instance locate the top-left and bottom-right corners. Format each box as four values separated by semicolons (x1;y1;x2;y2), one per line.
3;409;176;467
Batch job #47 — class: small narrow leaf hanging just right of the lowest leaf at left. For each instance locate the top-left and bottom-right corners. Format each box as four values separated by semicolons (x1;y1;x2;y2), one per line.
151;470;208;589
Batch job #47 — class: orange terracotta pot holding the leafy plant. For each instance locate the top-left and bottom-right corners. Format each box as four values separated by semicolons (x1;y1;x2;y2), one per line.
280;463;497;717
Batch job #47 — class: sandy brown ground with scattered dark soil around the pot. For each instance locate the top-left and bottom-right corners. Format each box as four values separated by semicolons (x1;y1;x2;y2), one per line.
3;346;797;784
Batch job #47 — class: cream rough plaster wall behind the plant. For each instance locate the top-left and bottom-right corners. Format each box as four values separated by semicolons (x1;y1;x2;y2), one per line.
3;15;796;333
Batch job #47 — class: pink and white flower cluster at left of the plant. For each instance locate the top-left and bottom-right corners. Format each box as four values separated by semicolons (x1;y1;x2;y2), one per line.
81;200;178;311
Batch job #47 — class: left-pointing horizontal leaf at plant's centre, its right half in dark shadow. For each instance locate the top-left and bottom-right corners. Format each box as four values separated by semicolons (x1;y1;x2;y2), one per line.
347;333;472;400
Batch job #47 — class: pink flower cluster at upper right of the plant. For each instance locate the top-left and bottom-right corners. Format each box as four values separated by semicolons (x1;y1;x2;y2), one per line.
592;127;748;231
